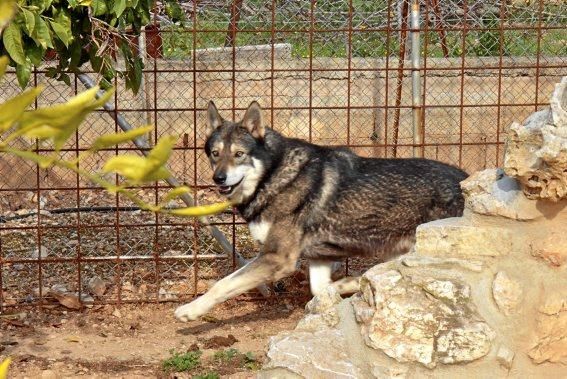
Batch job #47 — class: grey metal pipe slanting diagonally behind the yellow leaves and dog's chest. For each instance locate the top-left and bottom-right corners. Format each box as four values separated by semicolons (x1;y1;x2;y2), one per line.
77;74;270;297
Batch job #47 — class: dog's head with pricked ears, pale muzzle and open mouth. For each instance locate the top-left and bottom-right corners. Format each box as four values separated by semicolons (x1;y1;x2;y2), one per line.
205;101;266;204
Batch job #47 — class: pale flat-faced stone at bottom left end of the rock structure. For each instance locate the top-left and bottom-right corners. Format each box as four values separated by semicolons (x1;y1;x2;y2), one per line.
266;329;362;379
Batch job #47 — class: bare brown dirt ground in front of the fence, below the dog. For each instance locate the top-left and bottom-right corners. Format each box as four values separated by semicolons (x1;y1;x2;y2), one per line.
0;297;307;378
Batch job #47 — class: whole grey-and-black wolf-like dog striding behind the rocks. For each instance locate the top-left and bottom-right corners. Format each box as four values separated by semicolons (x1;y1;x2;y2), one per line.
175;102;467;321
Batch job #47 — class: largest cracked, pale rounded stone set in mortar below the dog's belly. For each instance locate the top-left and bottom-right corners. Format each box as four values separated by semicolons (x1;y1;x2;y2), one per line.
352;266;494;368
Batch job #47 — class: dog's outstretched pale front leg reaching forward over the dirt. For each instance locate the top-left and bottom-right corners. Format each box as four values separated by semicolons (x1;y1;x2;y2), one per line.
175;253;296;321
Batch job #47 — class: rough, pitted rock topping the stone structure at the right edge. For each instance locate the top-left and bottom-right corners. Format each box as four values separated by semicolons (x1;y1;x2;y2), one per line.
504;77;567;201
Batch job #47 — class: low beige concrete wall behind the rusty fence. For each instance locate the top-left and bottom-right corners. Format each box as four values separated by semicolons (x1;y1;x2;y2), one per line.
0;44;566;188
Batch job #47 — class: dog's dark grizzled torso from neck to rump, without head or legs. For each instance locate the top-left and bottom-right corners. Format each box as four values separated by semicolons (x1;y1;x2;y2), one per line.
240;134;467;259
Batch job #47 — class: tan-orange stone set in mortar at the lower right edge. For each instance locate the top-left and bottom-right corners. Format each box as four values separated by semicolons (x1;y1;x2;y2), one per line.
528;293;567;364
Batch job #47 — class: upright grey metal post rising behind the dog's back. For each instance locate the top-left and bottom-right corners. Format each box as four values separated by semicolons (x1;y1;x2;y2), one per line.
411;0;423;157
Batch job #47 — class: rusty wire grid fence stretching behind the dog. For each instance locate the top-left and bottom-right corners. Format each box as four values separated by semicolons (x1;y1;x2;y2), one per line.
0;0;567;308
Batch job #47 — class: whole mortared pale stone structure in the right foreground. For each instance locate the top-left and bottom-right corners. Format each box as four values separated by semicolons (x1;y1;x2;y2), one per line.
267;79;567;379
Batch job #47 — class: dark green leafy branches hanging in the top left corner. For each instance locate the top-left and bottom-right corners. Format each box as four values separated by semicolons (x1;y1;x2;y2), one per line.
0;0;153;92
